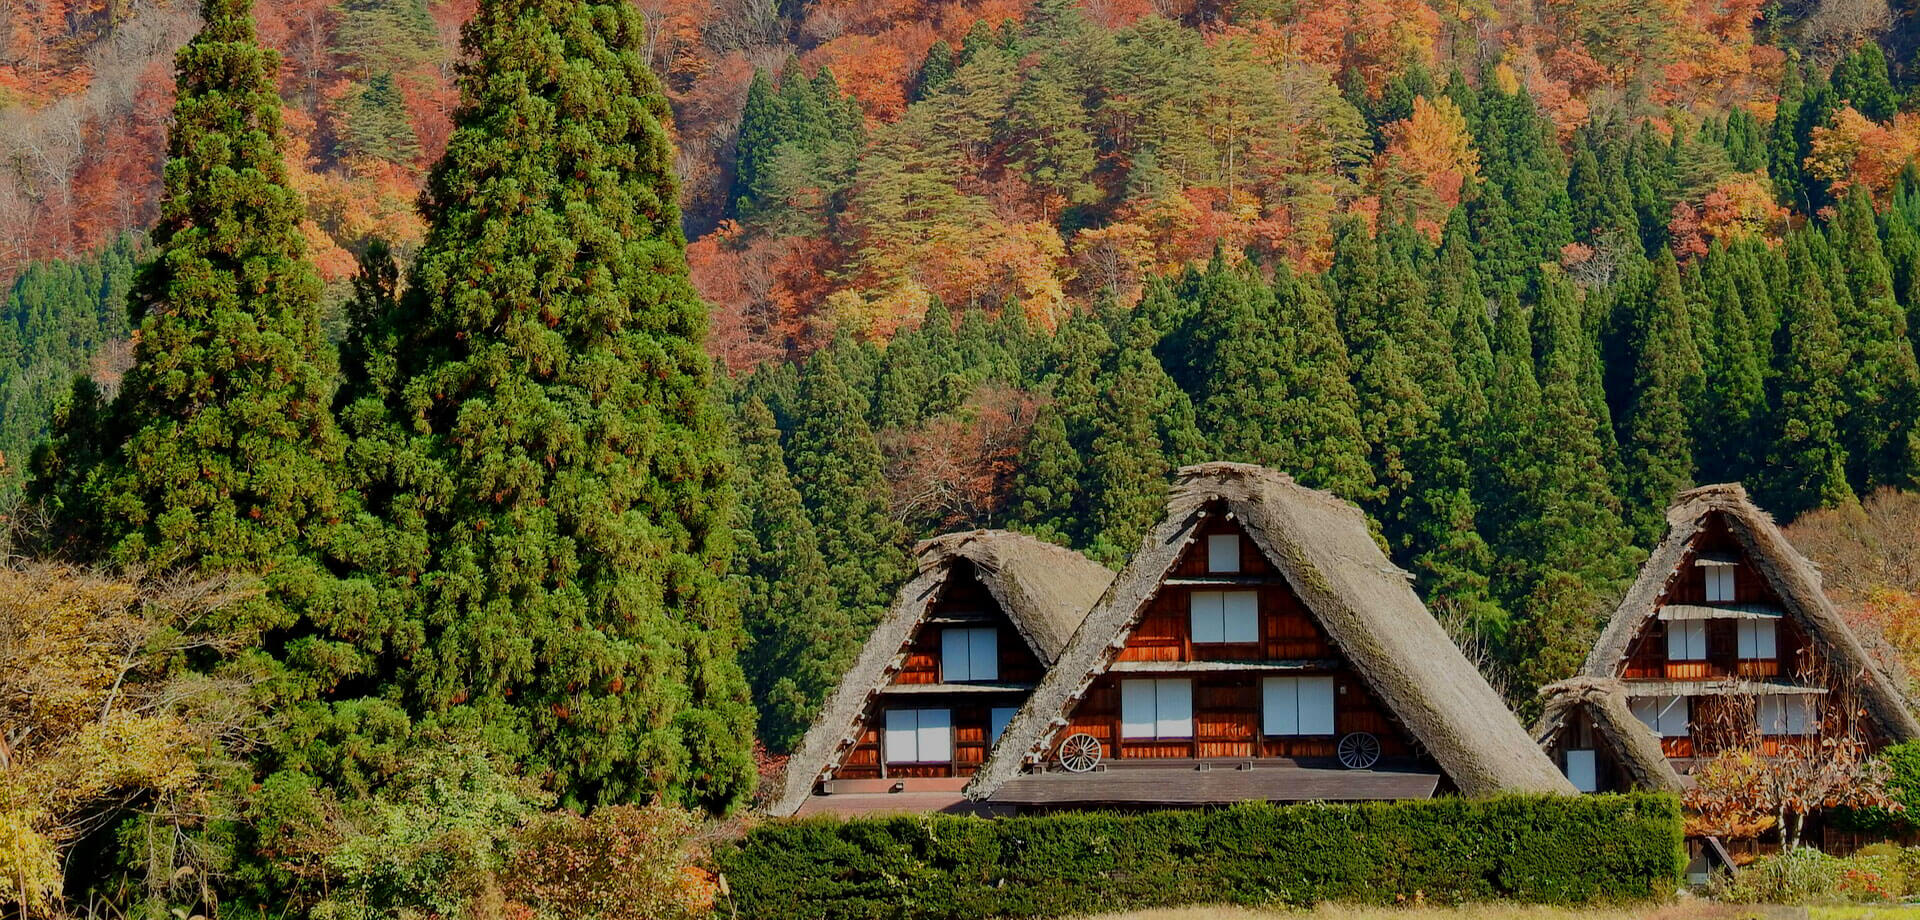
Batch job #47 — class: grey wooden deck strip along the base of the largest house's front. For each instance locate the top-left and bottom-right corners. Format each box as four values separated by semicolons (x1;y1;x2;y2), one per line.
989;763;1440;805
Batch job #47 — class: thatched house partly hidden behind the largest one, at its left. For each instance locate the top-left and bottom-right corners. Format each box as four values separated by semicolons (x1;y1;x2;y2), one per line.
768;530;1114;816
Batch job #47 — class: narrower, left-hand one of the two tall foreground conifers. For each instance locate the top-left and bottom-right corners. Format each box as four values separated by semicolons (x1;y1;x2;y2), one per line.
42;0;344;606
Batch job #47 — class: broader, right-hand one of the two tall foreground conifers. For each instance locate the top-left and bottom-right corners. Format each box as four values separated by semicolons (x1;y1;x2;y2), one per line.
378;0;753;811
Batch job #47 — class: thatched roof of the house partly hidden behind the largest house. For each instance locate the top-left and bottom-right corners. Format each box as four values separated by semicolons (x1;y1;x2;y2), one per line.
766;530;1114;816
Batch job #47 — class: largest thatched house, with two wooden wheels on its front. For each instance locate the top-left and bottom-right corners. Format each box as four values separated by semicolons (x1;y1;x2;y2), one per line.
968;463;1572;807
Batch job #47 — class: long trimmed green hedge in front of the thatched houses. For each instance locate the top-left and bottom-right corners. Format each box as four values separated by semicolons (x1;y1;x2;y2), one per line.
714;793;1684;920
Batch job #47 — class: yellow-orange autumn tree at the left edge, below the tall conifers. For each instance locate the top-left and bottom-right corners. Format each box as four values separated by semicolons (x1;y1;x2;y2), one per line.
0;563;269;918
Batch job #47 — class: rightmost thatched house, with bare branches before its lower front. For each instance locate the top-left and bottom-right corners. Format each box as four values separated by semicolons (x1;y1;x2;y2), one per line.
1582;484;1920;761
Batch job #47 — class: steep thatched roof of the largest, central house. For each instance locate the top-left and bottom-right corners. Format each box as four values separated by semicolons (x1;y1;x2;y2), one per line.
968;463;1572;799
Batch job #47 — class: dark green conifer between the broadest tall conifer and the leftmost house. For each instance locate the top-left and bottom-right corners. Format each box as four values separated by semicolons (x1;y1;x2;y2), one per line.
735;398;860;753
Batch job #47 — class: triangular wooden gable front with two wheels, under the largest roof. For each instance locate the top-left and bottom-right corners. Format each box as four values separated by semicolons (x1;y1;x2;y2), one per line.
1064;505;1415;764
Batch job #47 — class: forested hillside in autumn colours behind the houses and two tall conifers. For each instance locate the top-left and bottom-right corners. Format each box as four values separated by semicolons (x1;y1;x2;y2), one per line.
0;0;1920;722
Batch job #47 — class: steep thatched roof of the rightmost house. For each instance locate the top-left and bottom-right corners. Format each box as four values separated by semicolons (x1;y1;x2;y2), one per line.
1582;482;1920;741
